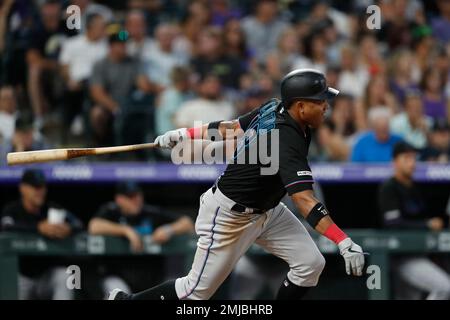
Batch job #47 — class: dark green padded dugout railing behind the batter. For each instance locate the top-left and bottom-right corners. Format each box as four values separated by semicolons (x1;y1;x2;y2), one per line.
0;229;450;299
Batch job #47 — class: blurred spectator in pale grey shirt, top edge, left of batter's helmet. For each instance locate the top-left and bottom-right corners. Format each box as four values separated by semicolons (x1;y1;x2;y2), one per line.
242;0;288;63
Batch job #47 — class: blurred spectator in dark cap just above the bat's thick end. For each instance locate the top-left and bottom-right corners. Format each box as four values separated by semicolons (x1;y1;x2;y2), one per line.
0;113;50;164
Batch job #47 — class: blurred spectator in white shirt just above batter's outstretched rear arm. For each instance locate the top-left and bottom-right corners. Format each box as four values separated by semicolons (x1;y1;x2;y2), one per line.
175;74;236;128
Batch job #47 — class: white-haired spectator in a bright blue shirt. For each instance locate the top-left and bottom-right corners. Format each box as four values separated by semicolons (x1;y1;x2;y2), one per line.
351;107;402;162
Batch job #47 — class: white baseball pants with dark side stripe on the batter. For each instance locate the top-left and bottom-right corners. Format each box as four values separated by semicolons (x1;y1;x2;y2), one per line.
175;188;325;300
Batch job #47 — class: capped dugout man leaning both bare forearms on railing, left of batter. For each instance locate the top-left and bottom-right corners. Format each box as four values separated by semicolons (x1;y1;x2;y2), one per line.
88;181;194;294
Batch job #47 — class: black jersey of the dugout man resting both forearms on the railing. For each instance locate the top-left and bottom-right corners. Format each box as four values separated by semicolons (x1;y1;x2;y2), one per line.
95;202;179;235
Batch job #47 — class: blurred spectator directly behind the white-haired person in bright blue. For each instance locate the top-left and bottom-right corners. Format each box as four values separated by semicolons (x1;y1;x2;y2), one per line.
355;74;397;131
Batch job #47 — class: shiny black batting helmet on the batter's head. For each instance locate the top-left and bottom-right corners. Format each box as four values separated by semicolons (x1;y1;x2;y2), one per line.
281;69;339;107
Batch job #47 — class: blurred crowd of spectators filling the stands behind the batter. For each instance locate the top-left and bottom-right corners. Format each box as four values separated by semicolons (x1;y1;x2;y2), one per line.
0;0;450;163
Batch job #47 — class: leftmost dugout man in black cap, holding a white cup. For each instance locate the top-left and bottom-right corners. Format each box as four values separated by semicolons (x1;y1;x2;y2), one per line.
0;169;82;300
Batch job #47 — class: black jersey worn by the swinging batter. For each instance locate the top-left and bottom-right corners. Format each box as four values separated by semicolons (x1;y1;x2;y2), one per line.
217;99;313;210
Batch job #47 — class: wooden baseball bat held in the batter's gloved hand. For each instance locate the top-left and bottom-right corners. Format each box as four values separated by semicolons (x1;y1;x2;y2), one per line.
7;143;158;165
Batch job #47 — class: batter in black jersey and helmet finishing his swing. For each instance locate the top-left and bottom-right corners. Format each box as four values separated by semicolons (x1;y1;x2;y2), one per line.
108;69;364;300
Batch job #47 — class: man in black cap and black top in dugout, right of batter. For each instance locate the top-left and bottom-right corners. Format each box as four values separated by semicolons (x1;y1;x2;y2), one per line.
378;142;450;300
